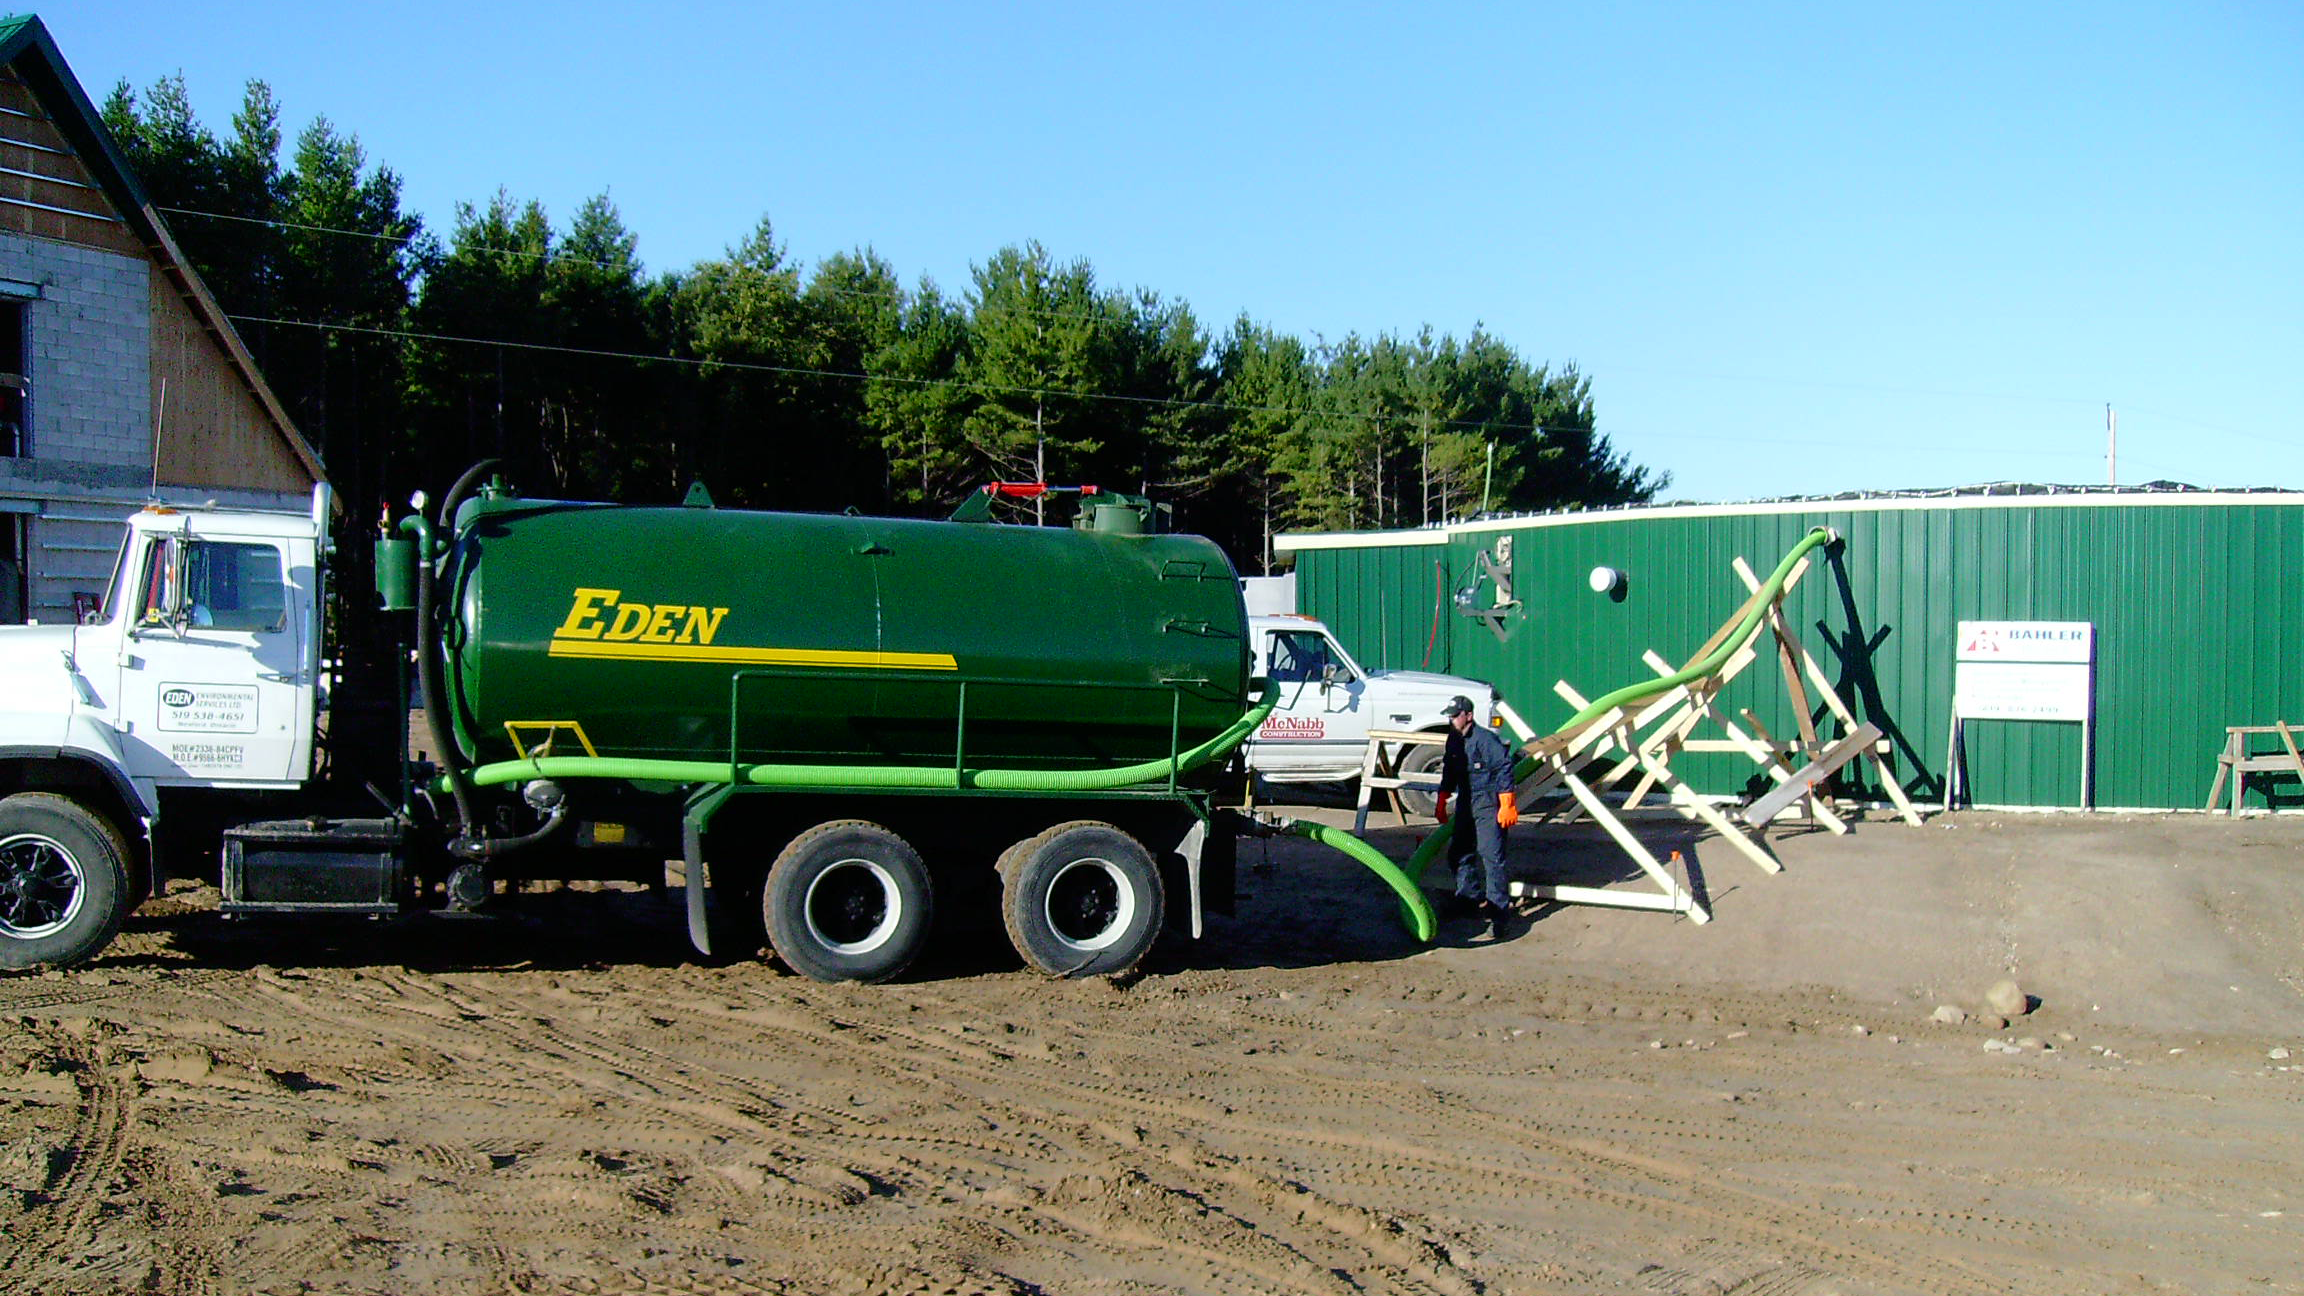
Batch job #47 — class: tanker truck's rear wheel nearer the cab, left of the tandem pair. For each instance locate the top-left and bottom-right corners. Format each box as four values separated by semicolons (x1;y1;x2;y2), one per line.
760;819;935;982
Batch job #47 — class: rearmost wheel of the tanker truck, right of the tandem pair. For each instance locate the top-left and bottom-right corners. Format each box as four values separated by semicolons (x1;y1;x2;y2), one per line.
1000;819;1164;978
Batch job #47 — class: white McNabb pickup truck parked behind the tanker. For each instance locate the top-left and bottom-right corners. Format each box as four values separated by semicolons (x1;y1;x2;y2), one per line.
1246;616;1495;812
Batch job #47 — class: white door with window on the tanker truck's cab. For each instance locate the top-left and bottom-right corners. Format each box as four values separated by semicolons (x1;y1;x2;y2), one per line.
118;533;316;784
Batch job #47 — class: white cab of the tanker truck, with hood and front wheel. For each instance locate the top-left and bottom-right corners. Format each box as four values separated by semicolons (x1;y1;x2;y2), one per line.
0;484;332;966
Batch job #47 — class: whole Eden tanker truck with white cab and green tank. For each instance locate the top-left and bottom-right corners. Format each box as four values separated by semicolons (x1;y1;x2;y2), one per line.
0;470;1270;980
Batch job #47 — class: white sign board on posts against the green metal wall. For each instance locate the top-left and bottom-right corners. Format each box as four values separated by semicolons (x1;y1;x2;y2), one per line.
1945;620;2097;809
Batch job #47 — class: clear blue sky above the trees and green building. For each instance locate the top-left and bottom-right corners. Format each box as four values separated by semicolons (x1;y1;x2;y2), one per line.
41;0;2304;500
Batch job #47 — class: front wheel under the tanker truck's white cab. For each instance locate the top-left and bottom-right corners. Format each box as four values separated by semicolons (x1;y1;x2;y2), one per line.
0;791;129;969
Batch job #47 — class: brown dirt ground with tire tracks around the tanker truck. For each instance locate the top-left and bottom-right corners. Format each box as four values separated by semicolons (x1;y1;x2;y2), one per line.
0;809;2304;1296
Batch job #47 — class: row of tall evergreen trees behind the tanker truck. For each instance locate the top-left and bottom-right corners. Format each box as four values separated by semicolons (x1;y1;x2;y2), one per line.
104;78;1668;574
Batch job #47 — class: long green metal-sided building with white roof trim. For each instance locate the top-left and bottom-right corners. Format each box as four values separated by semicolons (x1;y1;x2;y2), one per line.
1279;491;2304;809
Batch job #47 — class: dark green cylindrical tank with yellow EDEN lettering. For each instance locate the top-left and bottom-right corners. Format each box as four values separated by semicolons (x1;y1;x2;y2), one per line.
440;498;1249;770
